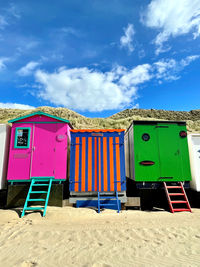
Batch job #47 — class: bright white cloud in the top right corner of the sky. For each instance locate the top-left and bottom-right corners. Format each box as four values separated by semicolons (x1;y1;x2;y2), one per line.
142;0;200;54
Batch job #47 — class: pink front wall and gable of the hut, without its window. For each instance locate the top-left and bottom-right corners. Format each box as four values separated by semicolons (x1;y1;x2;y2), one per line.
7;115;70;180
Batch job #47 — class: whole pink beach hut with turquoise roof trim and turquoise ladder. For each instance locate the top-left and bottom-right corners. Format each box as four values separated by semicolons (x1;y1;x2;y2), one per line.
7;111;72;216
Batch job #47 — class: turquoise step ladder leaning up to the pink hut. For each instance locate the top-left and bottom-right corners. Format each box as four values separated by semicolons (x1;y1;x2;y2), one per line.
21;178;53;218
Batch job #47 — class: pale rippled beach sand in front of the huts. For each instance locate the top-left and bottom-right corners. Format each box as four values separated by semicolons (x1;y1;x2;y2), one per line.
0;207;200;267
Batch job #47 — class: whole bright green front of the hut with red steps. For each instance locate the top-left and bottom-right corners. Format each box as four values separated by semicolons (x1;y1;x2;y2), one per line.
133;123;191;182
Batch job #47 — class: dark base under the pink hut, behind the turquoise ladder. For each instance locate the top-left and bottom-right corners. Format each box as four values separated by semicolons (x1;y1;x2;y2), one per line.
6;184;63;208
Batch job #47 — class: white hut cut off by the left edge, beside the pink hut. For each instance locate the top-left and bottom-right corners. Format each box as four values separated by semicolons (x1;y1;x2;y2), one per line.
0;124;11;190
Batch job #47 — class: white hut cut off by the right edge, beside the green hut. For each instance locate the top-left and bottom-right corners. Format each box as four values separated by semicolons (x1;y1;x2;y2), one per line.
188;134;200;192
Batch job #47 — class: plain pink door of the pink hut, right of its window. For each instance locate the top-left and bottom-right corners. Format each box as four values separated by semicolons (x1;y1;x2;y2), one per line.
31;123;57;177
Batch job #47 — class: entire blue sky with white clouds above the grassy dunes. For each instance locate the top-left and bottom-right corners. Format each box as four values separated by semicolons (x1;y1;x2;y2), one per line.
0;0;200;117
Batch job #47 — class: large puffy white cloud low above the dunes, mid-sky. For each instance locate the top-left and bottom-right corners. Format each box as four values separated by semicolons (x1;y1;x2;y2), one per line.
35;64;150;111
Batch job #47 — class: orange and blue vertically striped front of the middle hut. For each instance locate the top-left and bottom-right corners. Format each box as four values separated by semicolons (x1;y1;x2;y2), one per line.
70;131;126;192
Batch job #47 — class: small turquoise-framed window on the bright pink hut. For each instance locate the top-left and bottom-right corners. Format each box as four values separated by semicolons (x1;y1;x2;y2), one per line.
14;127;31;148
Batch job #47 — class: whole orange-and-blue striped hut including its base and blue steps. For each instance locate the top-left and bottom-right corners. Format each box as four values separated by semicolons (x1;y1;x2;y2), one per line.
70;129;126;214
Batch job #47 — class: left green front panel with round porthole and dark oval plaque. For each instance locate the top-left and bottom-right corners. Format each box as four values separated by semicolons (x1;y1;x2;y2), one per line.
134;125;160;182
